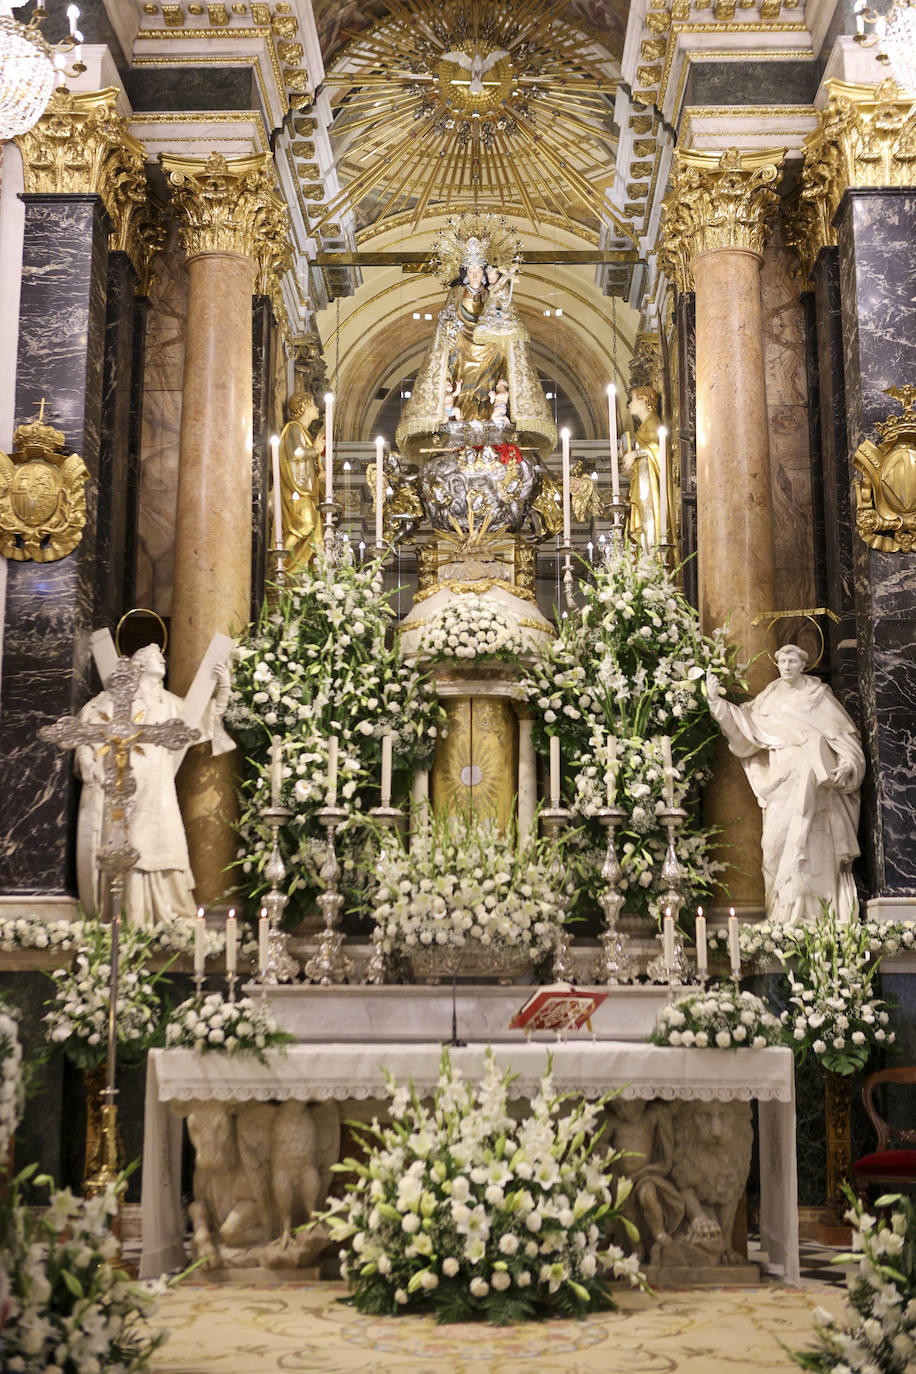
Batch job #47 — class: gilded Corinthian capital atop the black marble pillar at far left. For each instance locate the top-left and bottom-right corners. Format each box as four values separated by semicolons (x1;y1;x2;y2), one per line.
15;87;161;279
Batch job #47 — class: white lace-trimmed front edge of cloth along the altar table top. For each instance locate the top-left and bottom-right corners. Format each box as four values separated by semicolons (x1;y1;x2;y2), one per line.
150;1040;794;1102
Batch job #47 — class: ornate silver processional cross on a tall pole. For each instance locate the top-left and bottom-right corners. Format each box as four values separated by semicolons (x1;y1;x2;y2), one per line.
38;658;199;1191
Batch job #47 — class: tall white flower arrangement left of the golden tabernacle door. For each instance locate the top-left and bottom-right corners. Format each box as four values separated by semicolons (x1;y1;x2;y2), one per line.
225;559;445;922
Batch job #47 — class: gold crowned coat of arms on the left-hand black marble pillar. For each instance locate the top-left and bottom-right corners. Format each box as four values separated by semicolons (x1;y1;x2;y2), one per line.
0;401;89;563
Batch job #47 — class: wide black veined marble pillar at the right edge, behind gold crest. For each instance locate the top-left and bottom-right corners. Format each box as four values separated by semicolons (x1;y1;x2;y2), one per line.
835;190;916;897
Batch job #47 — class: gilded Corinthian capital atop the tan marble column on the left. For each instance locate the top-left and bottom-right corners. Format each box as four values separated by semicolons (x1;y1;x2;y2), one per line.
159;153;290;284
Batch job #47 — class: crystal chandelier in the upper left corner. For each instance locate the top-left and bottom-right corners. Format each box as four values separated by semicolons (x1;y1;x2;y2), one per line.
0;0;85;142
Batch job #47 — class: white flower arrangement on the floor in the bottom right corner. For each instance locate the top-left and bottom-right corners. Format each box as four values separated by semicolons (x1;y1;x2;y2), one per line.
790;1193;916;1374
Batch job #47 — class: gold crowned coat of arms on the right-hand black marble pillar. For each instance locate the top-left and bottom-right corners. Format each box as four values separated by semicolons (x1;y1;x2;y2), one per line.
853;386;916;554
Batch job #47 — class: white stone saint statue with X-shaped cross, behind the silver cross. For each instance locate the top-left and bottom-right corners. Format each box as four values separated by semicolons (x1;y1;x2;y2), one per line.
77;644;235;926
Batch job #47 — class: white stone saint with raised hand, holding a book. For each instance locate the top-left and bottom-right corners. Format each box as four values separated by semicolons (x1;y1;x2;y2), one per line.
706;644;865;925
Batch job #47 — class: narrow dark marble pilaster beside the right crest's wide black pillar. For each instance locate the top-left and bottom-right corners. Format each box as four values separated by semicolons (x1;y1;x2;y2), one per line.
809;247;858;720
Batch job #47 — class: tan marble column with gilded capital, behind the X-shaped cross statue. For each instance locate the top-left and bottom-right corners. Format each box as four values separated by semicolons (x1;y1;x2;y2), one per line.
161;154;287;905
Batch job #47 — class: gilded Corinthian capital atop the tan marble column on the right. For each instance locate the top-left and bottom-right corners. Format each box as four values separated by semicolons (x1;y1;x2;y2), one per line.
659;148;784;291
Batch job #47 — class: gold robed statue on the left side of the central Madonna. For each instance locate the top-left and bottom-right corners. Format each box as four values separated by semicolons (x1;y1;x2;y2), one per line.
280;392;324;573
